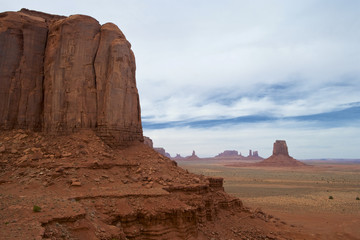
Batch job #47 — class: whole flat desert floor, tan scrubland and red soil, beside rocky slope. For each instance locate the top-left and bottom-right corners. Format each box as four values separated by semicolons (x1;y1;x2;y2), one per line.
179;160;360;239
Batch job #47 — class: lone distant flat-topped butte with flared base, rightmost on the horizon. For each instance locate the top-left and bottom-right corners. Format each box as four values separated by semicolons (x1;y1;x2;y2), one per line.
256;140;307;167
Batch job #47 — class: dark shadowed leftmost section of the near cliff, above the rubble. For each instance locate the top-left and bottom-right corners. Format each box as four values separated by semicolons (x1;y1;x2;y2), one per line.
0;12;52;129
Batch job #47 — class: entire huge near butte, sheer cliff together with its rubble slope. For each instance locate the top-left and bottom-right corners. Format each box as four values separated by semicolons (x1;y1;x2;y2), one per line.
0;10;309;240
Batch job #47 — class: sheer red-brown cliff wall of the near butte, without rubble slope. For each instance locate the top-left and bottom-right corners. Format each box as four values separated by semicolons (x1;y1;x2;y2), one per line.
0;10;143;145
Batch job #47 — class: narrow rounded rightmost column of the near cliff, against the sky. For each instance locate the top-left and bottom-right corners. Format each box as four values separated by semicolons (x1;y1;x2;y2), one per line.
94;23;142;144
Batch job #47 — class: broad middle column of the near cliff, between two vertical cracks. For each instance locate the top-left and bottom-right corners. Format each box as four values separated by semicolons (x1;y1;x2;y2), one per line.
44;15;100;132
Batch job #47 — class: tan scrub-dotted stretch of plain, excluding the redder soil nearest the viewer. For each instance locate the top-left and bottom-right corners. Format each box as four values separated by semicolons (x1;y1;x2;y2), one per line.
182;163;360;214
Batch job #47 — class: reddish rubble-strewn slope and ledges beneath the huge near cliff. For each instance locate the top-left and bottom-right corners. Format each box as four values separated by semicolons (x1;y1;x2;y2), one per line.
0;130;316;240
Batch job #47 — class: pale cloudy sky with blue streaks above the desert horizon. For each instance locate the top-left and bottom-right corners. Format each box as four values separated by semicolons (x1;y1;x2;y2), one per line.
0;0;360;159
